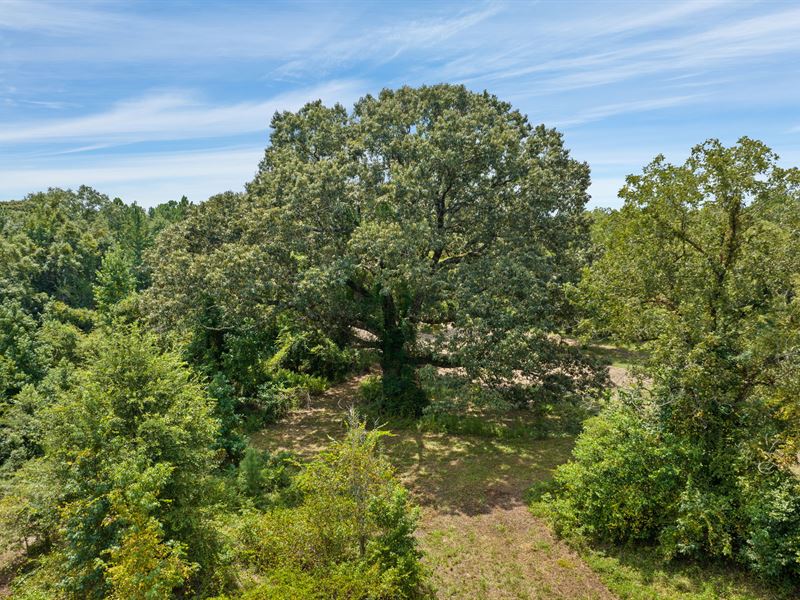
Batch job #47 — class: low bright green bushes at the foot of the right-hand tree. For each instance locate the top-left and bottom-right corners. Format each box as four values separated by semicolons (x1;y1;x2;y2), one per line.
548;390;800;582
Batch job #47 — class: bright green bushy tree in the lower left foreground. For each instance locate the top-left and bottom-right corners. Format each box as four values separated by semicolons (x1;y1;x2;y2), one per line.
8;327;225;597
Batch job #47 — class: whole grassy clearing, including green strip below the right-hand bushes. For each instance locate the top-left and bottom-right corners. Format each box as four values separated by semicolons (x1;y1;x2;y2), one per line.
252;380;793;600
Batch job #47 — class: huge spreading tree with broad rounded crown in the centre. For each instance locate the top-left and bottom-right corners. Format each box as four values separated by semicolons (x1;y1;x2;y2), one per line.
152;85;600;413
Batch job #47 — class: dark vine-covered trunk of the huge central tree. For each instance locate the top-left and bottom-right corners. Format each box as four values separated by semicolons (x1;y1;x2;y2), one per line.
381;294;427;417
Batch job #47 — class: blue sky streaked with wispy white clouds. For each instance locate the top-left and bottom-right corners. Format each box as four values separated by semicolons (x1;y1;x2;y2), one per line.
0;0;800;206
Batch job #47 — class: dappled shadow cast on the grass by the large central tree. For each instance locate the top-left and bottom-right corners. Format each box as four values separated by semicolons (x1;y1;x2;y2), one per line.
251;380;573;515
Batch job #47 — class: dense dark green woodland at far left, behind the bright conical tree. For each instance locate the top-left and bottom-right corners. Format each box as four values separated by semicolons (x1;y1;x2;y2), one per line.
0;187;192;473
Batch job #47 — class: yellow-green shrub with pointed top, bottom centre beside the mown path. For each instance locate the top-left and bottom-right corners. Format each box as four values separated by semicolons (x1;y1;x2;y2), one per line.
240;415;422;599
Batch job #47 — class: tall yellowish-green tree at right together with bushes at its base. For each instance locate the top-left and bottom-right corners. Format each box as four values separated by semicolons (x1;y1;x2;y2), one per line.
557;138;800;578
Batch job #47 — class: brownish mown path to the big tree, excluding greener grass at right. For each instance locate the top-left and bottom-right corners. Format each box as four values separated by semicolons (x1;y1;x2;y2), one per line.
253;380;614;600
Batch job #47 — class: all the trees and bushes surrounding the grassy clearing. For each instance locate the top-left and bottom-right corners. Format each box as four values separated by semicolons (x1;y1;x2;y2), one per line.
0;85;800;599
